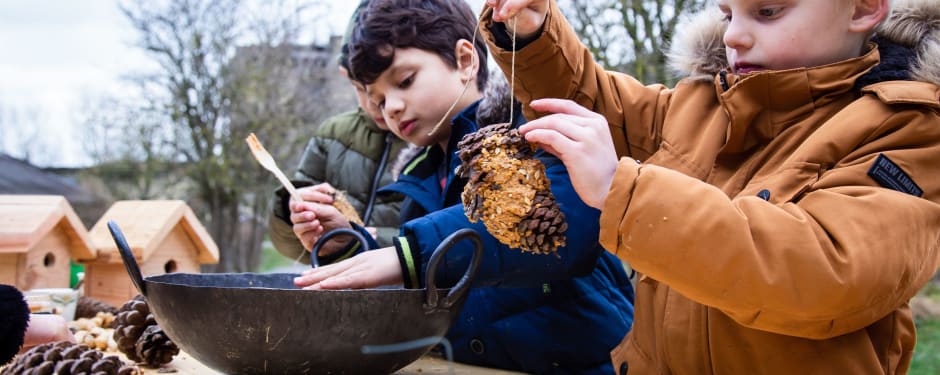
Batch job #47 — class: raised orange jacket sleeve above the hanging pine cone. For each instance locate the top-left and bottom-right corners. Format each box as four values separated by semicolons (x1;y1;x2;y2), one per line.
480;0;671;160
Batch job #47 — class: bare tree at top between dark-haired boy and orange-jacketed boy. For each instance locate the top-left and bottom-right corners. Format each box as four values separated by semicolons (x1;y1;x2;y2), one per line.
562;0;707;83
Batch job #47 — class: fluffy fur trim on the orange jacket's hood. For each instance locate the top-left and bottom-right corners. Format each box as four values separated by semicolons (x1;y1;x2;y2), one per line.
667;0;940;85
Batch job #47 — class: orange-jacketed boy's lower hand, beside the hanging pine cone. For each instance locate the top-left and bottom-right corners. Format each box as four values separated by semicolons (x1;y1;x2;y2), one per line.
519;99;617;209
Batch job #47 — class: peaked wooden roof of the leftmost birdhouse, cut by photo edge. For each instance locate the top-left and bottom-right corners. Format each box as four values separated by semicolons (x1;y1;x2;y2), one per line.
0;195;96;260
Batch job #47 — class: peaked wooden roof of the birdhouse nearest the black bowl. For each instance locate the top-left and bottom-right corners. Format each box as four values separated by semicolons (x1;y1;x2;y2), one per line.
89;200;219;264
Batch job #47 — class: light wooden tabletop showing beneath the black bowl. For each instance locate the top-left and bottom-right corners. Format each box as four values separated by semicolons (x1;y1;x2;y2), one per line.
134;352;518;375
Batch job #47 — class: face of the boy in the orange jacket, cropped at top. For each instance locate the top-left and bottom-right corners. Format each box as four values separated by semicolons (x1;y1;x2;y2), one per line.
718;0;874;74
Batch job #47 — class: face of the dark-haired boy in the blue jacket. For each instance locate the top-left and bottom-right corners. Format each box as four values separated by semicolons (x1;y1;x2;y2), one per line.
366;48;476;147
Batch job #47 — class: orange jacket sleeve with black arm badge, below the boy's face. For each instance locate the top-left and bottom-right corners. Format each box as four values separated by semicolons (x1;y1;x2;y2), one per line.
600;100;940;339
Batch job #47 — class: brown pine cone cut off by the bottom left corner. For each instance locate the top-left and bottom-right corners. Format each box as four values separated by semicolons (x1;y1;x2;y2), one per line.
0;341;140;375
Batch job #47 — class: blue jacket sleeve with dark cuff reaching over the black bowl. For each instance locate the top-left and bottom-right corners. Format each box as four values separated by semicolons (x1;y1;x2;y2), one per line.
396;152;604;287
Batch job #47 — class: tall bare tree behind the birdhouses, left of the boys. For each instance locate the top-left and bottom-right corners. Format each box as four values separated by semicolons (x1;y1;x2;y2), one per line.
86;0;352;272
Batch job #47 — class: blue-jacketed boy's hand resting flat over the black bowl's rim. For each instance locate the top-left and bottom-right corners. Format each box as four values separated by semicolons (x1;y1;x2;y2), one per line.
294;247;402;289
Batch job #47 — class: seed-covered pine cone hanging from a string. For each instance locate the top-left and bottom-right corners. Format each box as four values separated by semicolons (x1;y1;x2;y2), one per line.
457;123;568;254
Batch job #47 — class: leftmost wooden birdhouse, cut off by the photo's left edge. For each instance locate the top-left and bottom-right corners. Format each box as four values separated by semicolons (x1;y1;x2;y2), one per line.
0;195;96;291
